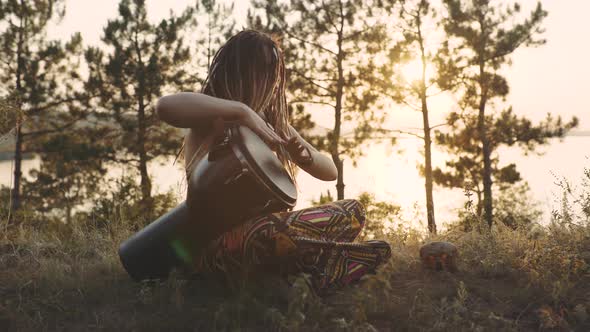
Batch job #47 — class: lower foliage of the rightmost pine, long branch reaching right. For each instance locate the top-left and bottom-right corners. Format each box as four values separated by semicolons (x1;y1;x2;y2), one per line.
433;107;578;214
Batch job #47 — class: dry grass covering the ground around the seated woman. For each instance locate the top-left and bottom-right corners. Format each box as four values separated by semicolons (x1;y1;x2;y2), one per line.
0;211;590;331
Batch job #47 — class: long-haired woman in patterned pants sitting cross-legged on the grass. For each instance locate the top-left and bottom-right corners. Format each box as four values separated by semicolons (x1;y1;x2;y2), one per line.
156;30;391;294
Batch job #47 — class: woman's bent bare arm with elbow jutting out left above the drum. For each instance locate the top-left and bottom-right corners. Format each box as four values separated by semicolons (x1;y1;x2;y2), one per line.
156;92;285;145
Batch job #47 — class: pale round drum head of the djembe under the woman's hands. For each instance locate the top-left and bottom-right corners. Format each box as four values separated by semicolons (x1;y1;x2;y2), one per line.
233;126;297;205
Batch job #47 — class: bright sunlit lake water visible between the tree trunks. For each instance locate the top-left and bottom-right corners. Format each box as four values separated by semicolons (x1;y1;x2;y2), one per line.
0;136;590;227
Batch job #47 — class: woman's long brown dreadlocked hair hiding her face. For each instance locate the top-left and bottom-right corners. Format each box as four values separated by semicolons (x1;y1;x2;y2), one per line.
175;30;295;181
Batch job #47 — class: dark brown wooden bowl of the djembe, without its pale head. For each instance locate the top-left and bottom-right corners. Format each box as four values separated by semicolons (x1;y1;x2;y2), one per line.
186;127;296;238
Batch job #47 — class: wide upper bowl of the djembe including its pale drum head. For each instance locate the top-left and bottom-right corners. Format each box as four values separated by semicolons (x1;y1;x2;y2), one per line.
186;126;297;239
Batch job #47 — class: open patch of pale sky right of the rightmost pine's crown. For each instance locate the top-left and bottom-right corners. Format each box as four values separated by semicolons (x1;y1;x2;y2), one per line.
507;0;590;130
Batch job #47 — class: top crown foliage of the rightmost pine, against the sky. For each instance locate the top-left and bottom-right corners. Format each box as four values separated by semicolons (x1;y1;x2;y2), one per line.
441;0;547;89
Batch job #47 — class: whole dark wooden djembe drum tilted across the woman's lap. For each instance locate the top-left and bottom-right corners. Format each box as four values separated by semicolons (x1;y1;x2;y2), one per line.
119;125;297;280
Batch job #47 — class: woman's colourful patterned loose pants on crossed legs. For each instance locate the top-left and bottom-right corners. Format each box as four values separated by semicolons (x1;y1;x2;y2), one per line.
196;199;391;294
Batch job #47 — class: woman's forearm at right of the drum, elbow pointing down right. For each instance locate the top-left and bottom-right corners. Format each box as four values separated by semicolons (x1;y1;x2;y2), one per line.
287;125;338;181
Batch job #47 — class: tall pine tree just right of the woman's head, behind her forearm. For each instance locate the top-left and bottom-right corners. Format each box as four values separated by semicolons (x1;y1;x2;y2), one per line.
253;0;384;199
